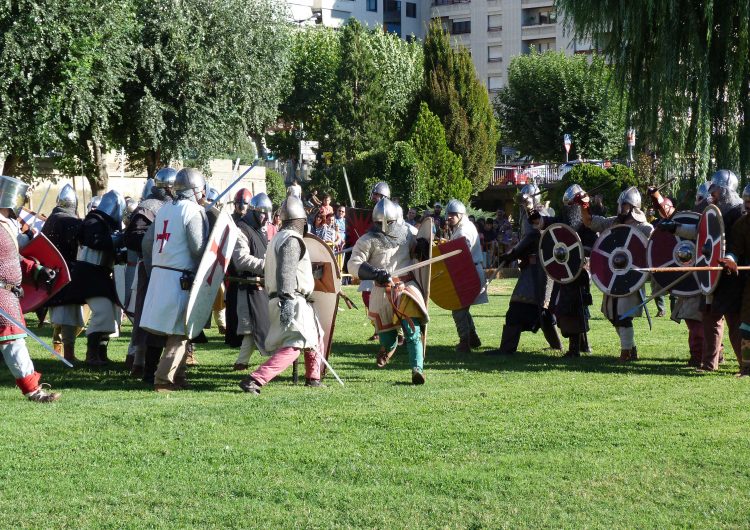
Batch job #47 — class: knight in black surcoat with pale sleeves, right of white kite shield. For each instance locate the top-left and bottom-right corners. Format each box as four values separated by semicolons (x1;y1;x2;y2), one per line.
230;193;273;371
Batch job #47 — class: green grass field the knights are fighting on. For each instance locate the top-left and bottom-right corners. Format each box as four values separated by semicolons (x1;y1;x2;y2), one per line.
0;280;750;528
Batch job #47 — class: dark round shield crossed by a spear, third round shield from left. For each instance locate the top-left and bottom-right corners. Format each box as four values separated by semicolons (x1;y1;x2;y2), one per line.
648;211;701;296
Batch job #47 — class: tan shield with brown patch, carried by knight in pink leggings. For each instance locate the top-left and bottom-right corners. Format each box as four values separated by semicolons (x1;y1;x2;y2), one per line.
305;234;341;375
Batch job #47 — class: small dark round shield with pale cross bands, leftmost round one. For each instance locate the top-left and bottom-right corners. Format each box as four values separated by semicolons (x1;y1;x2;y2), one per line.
539;223;583;283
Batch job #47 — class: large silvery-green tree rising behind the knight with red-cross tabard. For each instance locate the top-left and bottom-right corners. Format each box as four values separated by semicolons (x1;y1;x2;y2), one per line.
117;0;291;176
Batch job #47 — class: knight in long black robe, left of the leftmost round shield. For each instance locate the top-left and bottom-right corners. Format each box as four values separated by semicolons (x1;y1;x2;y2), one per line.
489;184;562;355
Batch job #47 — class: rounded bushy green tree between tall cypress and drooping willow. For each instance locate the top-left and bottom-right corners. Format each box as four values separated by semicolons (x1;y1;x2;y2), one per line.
496;52;625;161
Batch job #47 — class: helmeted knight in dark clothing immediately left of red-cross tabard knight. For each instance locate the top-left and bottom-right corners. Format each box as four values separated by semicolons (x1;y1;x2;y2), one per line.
124;167;177;378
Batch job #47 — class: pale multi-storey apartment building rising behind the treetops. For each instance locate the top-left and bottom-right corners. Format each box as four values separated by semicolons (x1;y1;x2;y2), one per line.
287;0;592;96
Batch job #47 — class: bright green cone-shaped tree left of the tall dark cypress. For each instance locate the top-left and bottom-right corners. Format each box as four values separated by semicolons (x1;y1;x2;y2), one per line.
409;103;472;203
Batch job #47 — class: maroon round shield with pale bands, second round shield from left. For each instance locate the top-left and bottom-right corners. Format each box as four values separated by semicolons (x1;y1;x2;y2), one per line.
590;225;648;296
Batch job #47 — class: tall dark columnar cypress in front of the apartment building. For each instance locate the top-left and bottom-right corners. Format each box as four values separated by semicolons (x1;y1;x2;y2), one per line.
424;21;499;192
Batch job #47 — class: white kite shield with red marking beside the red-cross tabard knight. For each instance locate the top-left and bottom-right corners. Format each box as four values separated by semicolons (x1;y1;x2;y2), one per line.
185;211;239;339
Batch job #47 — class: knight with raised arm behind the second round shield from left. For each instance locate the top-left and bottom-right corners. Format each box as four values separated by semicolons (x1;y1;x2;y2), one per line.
574;186;654;362
